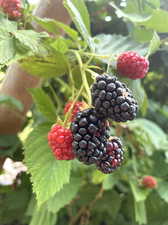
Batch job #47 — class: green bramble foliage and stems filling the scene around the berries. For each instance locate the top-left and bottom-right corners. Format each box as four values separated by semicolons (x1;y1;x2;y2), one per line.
0;0;168;225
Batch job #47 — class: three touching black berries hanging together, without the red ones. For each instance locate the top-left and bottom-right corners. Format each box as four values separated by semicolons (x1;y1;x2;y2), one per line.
71;74;138;173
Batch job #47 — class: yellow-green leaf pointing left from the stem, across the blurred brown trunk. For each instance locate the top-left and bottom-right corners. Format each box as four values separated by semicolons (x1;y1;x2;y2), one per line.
21;52;68;78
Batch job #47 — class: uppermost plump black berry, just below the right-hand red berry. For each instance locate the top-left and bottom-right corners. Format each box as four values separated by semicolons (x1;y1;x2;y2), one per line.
91;74;138;122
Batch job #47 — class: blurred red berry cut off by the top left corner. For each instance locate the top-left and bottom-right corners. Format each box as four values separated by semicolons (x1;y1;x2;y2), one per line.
0;0;22;18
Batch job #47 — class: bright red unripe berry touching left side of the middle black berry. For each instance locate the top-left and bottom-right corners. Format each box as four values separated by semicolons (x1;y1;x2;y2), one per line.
48;124;75;160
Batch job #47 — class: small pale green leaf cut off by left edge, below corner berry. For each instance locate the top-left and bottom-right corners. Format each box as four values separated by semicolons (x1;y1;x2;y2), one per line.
0;36;15;64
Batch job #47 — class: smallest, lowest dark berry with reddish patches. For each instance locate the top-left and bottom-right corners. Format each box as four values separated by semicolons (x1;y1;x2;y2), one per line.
97;137;124;174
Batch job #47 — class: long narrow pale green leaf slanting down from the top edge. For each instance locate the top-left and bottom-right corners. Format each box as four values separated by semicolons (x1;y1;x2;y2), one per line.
64;0;95;51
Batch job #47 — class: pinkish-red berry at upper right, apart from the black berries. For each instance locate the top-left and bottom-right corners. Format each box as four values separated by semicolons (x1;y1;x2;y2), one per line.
117;51;149;79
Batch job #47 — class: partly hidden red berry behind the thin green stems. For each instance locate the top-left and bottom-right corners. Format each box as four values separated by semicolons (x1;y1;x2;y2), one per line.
64;101;86;121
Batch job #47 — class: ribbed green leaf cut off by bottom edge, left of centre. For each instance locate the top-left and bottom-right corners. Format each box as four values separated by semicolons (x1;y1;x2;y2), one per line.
30;205;57;225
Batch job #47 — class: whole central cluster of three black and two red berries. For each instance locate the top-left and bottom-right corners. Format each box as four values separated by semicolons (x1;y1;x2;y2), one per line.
48;74;138;174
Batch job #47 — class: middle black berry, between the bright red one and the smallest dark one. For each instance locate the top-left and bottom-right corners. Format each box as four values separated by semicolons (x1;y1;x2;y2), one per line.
71;108;108;165
